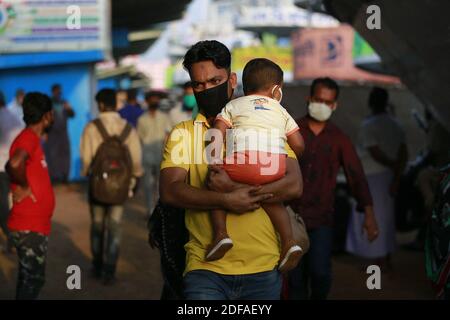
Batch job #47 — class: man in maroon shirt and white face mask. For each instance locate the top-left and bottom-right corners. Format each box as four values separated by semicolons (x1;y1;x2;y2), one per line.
289;78;378;299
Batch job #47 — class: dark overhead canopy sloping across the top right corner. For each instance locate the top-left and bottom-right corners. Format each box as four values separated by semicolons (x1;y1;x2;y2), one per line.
323;0;450;128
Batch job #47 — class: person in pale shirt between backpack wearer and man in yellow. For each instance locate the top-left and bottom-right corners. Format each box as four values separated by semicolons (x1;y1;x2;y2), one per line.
136;91;171;216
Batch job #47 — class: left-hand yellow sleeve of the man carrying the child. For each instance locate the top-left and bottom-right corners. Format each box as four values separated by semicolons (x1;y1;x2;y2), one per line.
160;122;191;171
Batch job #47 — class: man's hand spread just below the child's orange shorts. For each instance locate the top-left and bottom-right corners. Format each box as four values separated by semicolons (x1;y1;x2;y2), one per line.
223;186;273;213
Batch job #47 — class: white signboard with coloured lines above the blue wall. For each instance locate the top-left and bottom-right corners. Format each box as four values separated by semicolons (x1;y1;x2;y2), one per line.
0;0;110;53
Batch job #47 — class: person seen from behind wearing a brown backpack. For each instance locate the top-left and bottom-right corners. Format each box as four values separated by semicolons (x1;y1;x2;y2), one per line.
80;89;143;285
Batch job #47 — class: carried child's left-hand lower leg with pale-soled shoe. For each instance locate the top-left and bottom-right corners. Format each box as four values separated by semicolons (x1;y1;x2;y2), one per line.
205;210;233;261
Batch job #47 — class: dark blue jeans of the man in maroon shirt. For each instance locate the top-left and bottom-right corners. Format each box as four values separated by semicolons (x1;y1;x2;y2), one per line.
289;226;333;300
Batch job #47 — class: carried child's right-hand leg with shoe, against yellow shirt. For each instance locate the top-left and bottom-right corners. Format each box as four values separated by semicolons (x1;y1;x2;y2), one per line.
261;203;302;272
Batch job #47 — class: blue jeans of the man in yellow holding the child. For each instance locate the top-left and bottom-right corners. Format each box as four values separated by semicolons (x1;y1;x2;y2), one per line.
184;270;281;300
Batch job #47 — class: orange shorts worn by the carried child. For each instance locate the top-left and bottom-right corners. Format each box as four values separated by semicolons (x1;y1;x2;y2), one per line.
222;151;287;185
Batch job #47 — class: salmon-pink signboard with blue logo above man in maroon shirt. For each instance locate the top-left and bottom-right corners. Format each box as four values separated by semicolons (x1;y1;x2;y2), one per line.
292;25;399;83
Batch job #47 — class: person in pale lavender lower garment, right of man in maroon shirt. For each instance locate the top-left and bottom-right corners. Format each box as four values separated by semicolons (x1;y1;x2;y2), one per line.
346;87;408;271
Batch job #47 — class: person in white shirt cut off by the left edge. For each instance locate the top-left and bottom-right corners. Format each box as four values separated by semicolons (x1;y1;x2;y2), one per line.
0;92;25;252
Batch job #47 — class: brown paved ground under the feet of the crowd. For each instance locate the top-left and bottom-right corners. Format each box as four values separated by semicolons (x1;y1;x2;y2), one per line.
0;185;433;299
